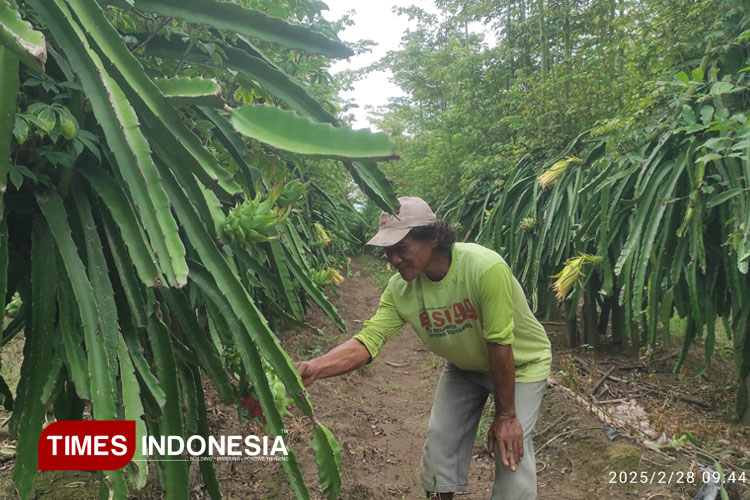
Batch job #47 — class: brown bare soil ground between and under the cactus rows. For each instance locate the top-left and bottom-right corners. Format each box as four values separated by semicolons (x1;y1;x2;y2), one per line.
0;257;750;500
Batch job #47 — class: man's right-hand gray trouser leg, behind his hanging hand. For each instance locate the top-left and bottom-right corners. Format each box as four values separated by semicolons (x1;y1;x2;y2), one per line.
492;380;547;500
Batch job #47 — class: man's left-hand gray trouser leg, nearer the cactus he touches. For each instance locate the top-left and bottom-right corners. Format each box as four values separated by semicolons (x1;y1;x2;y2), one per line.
420;362;489;499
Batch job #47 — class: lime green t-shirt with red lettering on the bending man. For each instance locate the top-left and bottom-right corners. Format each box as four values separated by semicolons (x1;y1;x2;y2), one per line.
354;243;552;382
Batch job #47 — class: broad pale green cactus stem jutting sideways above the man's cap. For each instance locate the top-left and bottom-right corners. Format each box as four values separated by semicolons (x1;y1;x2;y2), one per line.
232;105;398;160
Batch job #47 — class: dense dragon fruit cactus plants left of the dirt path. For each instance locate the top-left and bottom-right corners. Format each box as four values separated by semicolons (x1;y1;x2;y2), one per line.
0;0;397;499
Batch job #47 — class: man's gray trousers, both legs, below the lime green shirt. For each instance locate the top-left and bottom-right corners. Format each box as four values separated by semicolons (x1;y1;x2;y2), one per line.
420;362;547;500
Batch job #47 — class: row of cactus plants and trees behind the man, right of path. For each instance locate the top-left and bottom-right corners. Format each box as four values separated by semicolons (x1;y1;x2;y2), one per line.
378;0;750;423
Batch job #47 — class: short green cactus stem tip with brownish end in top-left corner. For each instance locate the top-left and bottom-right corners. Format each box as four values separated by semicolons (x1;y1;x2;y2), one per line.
0;1;47;73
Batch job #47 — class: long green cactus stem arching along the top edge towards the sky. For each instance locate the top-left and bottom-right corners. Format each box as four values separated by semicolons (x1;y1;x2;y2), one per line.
110;0;354;58
